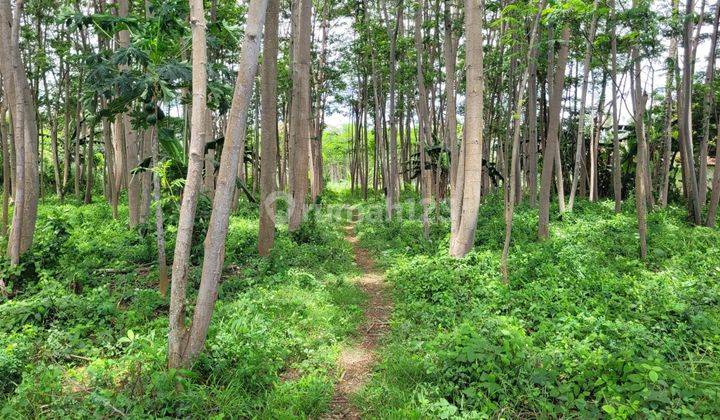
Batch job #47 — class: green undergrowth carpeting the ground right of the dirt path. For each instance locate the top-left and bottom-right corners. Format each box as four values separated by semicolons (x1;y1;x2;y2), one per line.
357;197;720;418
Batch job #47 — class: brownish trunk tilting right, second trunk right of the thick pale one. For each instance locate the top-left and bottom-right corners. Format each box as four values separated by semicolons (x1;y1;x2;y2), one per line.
538;26;570;239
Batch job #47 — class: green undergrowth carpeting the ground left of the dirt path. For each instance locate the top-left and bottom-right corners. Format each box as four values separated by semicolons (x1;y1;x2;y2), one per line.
0;196;364;418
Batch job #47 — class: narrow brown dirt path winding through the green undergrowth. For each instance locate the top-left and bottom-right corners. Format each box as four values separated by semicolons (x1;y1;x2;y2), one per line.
324;223;392;419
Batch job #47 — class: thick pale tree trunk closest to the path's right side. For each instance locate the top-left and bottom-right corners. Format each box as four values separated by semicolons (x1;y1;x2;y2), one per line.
450;0;485;258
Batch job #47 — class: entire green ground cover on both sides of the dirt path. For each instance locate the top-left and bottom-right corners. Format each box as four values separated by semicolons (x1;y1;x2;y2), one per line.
5;190;720;418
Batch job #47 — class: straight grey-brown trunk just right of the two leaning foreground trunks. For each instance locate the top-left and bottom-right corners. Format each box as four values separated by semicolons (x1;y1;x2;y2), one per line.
258;0;280;256
